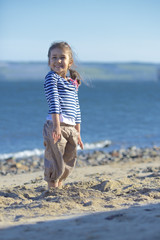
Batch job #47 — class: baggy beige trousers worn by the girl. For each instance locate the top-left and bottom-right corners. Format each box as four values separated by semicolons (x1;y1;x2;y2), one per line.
43;120;78;182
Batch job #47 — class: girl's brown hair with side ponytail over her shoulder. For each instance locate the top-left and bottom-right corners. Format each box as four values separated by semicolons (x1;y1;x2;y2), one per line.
48;42;81;85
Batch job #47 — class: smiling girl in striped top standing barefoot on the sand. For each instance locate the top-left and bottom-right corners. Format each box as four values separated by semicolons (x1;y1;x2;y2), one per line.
43;42;83;188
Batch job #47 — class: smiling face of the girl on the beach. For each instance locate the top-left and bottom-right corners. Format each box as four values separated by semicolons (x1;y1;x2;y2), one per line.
49;48;72;78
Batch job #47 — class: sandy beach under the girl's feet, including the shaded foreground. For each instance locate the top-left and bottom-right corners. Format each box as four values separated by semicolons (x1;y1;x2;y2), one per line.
0;148;160;240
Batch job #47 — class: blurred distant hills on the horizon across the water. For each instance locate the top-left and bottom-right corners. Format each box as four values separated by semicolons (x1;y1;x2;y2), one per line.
0;62;160;81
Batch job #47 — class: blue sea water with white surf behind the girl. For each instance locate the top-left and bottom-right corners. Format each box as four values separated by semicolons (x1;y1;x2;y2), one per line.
0;80;160;159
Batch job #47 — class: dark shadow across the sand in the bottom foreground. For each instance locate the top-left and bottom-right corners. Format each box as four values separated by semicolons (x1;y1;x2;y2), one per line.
0;203;160;240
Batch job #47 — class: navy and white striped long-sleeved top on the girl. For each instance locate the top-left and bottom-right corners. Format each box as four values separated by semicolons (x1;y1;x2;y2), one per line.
44;71;81;124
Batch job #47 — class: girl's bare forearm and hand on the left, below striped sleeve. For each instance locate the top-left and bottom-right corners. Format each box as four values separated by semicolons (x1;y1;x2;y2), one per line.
52;113;61;143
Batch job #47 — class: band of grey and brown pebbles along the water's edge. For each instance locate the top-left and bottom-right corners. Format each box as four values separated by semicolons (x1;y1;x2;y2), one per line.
0;146;160;176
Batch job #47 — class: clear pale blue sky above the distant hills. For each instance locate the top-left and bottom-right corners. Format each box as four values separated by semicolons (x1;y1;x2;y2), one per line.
0;0;160;63
